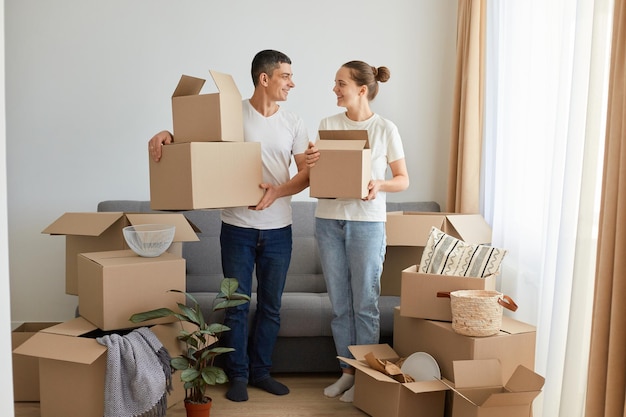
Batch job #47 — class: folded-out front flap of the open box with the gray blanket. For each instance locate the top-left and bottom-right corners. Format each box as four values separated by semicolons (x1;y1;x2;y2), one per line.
13;331;107;365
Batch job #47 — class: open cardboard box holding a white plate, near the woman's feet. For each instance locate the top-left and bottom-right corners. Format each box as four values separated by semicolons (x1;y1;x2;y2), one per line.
339;345;448;417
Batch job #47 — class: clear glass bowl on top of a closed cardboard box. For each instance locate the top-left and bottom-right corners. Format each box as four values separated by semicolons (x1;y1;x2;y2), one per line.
123;224;176;258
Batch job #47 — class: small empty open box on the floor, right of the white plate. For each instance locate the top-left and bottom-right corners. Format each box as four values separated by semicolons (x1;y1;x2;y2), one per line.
450;359;545;417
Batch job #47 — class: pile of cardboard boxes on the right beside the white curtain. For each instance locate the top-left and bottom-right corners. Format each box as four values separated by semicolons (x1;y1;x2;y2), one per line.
340;212;544;417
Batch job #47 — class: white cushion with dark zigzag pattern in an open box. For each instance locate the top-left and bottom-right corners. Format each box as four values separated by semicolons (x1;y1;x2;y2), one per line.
419;227;507;277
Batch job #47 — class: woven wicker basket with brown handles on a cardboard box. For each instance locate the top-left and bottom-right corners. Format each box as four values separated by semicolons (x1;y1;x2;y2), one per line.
438;290;517;336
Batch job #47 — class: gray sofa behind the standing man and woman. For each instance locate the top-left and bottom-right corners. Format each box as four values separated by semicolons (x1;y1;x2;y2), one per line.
98;200;440;373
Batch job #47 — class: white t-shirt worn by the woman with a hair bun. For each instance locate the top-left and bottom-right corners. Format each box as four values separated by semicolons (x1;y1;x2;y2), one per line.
312;112;404;222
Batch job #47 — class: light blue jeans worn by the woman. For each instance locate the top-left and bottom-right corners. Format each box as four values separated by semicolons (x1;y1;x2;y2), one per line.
315;218;386;367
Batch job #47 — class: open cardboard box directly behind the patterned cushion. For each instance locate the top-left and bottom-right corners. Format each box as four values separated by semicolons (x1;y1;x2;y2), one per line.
381;211;491;296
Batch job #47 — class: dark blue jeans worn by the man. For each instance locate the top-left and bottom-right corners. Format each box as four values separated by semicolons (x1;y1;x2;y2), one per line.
220;223;292;382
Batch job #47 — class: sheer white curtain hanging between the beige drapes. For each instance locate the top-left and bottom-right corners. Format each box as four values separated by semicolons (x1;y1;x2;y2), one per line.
481;0;612;417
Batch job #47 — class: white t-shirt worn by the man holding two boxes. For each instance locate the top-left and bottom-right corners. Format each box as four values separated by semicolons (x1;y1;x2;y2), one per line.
222;99;309;230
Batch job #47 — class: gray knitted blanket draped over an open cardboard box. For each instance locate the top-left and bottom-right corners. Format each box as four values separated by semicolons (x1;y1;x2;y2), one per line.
96;327;172;417
